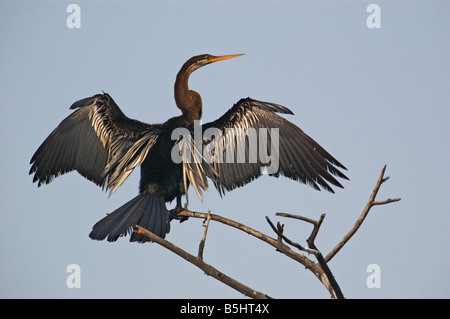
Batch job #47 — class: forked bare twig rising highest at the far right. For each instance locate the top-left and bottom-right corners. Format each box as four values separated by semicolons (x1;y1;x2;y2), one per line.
325;165;401;262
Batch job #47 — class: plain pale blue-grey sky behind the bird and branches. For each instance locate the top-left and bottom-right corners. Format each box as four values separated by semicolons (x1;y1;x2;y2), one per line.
0;0;450;299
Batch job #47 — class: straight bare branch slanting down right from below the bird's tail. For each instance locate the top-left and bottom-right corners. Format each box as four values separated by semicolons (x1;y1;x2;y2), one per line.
134;225;271;299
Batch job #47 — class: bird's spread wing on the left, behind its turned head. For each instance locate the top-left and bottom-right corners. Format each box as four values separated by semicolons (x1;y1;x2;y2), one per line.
30;93;160;193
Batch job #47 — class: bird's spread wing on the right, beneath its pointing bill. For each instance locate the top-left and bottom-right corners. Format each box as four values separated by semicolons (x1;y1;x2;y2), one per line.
196;98;348;194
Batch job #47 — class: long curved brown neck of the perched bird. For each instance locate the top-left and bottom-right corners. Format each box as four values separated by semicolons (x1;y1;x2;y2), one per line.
175;63;202;123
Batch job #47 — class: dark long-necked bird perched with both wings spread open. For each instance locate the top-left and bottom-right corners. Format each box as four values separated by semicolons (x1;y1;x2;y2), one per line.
29;54;348;243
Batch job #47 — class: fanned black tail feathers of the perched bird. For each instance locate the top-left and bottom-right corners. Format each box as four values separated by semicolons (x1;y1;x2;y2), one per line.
89;193;170;243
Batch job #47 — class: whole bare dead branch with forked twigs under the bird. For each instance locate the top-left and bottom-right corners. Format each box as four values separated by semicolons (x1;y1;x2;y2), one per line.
134;166;400;298
